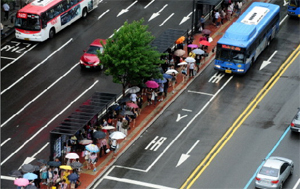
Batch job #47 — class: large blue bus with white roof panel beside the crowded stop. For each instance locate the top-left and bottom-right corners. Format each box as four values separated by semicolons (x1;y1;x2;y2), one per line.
214;2;280;74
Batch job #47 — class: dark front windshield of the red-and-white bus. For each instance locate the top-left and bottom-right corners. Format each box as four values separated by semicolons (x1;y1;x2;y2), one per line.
15;14;41;31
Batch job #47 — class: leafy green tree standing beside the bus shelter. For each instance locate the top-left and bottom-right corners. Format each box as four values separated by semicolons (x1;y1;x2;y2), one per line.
98;19;163;96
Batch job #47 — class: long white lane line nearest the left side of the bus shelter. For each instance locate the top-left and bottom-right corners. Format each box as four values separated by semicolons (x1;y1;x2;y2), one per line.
1;80;99;166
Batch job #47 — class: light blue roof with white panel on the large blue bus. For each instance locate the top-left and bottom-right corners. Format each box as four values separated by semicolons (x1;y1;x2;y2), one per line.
218;2;280;48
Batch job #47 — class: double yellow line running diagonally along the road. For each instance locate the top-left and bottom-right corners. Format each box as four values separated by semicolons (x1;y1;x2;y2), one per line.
180;45;300;189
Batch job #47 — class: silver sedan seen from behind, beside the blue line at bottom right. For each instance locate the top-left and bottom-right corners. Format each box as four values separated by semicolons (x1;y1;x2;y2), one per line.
255;156;294;189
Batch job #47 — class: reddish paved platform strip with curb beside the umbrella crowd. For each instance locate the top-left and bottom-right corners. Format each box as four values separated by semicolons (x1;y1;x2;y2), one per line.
15;0;266;189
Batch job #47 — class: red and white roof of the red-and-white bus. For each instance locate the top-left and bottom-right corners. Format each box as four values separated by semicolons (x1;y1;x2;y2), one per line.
19;0;61;15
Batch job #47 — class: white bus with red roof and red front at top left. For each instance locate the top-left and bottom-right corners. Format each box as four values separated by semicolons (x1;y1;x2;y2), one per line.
15;0;99;42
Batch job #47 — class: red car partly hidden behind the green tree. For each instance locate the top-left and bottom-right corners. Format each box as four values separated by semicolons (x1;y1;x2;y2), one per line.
79;39;106;69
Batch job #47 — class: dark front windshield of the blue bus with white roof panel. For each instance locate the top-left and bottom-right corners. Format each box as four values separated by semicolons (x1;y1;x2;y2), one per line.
217;49;245;63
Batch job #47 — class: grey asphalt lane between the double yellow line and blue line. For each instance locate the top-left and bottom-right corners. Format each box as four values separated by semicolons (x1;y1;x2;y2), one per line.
186;47;299;188
